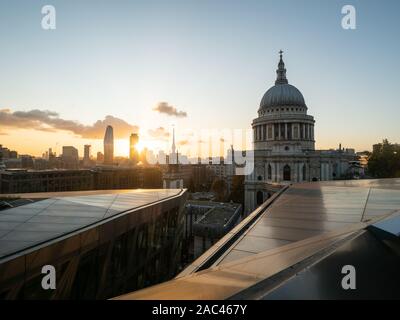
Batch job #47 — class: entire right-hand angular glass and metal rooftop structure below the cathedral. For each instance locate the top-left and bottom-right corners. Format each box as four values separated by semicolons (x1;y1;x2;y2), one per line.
118;179;400;299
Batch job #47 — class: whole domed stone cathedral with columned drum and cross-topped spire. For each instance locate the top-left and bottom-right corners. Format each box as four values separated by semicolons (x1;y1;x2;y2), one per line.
245;51;356;212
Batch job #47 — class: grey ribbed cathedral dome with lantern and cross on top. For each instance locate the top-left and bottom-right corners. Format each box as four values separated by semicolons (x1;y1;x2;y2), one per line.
260;51;306;109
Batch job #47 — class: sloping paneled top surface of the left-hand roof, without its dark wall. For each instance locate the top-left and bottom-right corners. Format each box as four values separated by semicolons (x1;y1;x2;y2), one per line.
0;189;182;260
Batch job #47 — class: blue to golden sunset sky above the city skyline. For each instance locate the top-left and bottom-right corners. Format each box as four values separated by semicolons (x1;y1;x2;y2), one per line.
0;0;400;156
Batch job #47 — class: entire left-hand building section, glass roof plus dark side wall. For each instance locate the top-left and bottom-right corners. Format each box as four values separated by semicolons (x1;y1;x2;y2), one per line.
0;189;187;300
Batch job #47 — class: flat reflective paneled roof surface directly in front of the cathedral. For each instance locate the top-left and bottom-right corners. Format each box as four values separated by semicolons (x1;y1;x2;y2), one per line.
195;179;400;265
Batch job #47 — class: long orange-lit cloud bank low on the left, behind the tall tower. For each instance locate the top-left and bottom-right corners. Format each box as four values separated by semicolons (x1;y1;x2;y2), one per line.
0;109;139;139
